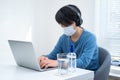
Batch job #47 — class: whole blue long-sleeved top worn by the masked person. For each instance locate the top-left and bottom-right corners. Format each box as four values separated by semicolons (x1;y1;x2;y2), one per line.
48;29;99;71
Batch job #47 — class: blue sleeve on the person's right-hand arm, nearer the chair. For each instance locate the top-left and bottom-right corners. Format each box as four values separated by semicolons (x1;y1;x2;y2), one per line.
77;36;97;69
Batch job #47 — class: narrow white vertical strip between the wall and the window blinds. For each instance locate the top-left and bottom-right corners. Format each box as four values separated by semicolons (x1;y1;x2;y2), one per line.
95;0;109;49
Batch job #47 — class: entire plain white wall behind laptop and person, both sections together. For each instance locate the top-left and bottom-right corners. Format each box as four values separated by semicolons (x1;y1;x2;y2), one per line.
0;0;95;64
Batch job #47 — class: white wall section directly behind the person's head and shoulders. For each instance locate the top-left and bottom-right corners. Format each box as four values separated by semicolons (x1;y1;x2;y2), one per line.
32;0;95;55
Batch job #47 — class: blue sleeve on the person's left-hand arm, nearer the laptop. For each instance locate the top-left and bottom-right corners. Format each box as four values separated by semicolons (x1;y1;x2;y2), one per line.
48;36;62;60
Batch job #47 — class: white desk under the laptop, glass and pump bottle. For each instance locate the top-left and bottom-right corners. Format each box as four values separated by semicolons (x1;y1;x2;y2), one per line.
0;65;94;80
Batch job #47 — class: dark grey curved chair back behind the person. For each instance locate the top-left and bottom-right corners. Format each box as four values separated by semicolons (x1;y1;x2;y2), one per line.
94;47;111;80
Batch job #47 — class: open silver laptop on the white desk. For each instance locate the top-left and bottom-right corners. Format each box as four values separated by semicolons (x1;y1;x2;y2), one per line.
8;40;53;71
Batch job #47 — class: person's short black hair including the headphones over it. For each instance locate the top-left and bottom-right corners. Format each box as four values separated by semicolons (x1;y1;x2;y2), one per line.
55;5;83;26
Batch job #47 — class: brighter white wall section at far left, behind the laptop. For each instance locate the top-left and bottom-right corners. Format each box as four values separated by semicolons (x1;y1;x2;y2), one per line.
0;0;34;64
